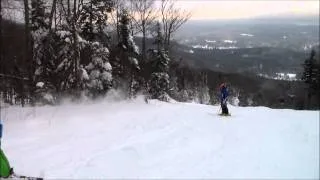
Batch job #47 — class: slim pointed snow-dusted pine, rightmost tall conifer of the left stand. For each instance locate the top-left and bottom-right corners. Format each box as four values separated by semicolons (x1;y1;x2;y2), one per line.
149;22;170;101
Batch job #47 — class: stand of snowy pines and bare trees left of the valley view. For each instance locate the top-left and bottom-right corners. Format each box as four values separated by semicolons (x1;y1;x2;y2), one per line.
0;0;214;105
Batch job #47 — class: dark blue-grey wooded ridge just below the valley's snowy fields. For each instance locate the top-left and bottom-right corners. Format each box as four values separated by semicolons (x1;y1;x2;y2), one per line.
170;45;308;75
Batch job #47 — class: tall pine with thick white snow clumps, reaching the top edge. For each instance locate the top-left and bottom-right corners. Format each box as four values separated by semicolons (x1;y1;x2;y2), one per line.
78;0;113;97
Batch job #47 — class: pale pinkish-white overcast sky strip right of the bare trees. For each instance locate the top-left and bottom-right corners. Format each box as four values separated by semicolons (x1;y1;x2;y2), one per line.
172;0;319;19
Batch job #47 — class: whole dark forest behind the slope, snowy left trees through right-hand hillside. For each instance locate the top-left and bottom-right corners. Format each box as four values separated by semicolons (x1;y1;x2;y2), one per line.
0;0;319;109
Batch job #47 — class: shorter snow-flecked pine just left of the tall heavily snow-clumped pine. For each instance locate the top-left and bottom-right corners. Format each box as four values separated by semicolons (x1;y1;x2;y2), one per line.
35;28;76;104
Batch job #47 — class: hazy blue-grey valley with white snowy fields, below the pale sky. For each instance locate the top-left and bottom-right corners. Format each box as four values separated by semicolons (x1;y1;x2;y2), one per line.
173;19;319;78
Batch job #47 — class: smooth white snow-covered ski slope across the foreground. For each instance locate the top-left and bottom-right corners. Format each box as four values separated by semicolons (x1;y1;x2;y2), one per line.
2;98;319;179
